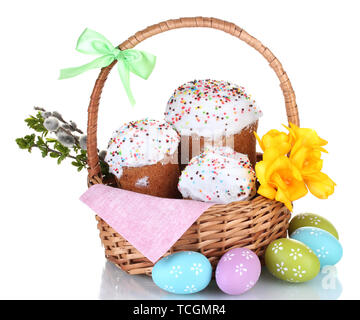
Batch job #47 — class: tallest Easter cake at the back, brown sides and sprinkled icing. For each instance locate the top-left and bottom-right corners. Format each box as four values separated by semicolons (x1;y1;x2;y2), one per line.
165;79;262;166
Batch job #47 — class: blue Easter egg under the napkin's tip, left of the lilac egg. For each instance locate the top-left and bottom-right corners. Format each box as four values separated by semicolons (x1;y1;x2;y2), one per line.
152;251;212;294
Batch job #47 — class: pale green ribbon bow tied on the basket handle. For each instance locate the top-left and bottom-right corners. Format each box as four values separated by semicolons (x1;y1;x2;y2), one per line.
59;29;156;105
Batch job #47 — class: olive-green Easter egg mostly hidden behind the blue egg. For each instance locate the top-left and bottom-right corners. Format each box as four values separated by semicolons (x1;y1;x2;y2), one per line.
289;213;339;240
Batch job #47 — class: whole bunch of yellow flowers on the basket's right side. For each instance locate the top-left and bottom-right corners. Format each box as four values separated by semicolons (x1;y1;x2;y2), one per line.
254;123;336;206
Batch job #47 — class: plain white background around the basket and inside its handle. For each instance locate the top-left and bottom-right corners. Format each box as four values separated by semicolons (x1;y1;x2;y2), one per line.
0;0;360;299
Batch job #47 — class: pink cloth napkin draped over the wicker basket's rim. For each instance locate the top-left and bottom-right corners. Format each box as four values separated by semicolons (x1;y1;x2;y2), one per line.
80;184;213;263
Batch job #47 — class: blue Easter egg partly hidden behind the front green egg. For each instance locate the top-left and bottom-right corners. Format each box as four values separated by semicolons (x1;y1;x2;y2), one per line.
290;227;343;268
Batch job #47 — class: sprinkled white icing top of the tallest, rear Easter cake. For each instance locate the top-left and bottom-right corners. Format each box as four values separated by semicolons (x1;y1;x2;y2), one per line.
165;80;262;138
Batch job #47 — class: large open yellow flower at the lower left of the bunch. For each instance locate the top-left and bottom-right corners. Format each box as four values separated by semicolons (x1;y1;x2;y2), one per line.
255;148;308;211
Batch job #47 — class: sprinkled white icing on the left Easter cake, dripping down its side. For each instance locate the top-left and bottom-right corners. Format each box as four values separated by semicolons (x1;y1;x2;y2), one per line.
105;119;180;178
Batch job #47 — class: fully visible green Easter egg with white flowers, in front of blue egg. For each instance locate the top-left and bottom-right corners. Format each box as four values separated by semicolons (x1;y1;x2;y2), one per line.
265;238;320;282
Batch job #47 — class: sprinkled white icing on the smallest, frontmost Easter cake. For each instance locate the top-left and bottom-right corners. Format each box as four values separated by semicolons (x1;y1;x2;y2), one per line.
178;147;256;204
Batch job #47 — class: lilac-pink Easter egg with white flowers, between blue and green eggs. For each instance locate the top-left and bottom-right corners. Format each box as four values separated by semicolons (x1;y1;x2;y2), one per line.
215;248;261;295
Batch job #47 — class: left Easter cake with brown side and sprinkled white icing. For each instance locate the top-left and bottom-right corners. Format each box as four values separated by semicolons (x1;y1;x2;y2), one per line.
105;119;180;198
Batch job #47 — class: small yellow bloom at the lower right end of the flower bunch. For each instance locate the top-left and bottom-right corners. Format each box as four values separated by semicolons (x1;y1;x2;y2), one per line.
304;172;336;199
